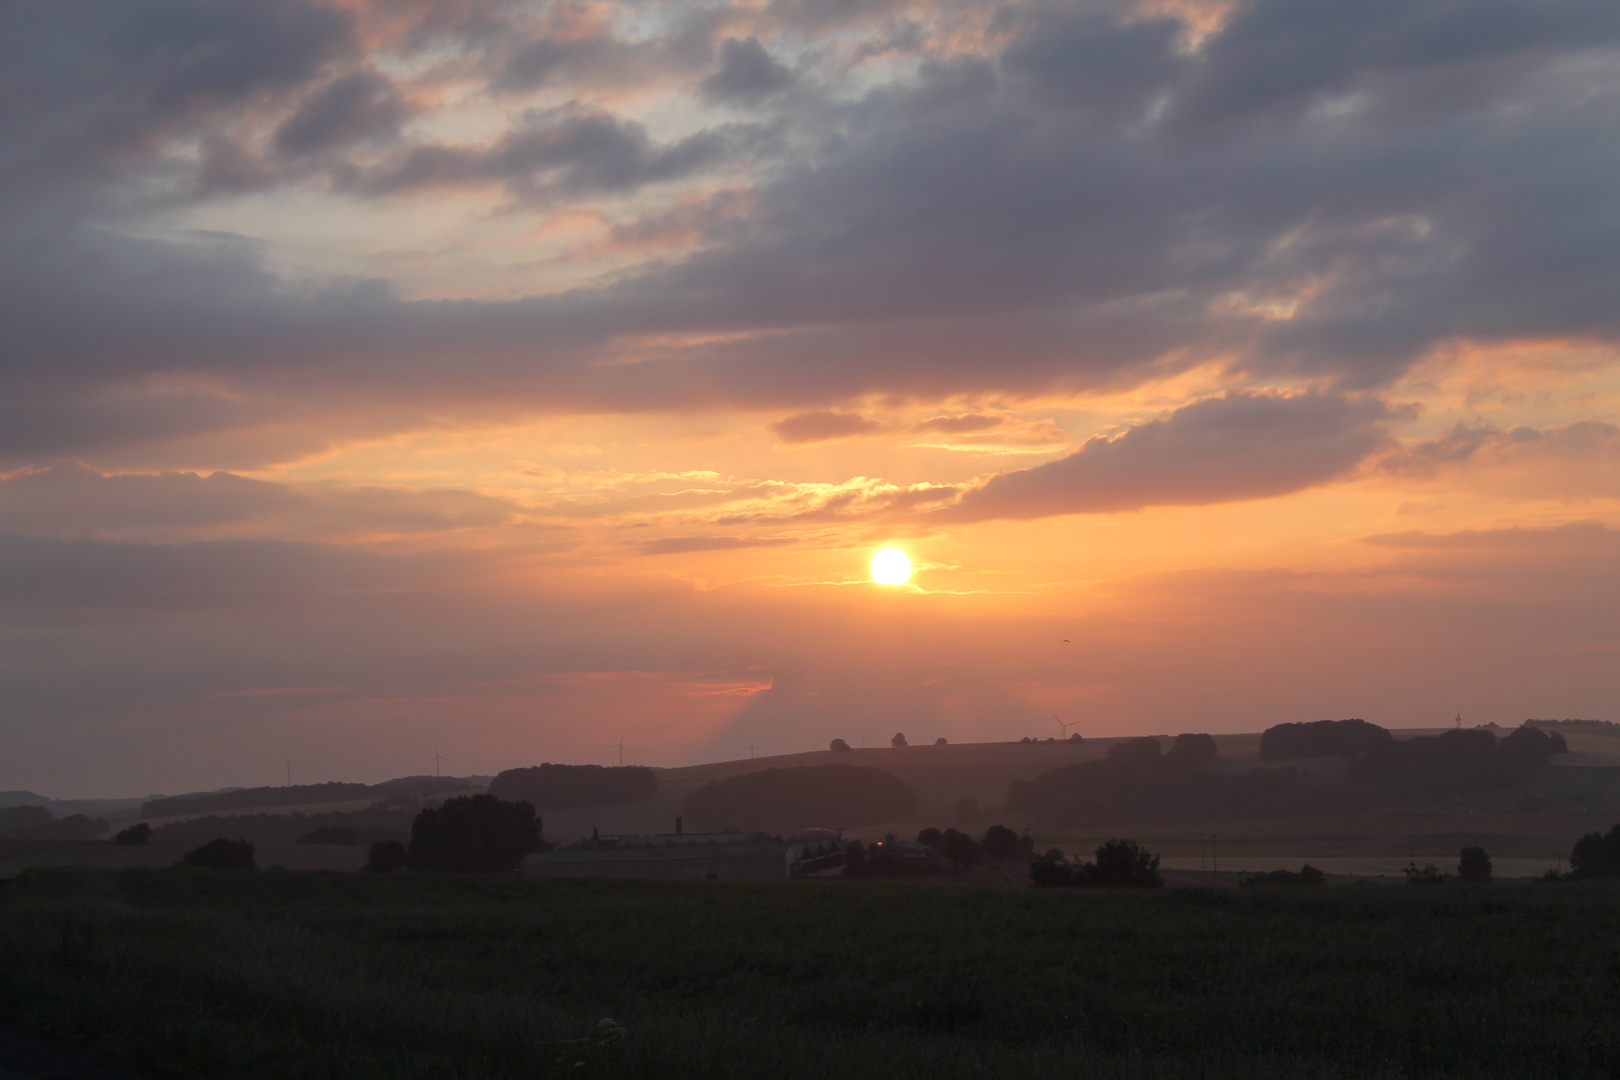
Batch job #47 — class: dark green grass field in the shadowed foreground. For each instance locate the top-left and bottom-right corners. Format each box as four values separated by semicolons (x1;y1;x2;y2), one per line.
0;870;1620;1080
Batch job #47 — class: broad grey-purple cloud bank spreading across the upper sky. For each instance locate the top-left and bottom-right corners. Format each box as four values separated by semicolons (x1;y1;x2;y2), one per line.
0;0;1620;498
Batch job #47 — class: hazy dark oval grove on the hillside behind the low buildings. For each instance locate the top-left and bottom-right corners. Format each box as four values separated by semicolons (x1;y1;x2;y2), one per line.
680;764;917;834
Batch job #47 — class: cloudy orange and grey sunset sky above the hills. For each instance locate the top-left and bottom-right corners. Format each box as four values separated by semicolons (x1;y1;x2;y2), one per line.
0;0;1620;798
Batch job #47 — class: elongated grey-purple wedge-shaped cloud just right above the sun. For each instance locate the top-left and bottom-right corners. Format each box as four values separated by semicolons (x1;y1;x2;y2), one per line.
941;390;1390;521
